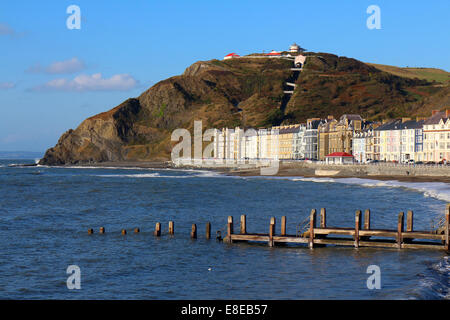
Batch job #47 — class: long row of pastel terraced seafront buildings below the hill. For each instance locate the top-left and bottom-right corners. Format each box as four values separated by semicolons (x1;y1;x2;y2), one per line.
213;109;450;163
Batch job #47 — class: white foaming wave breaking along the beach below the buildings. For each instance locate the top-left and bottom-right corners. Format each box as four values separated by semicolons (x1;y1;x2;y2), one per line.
289;177;450;202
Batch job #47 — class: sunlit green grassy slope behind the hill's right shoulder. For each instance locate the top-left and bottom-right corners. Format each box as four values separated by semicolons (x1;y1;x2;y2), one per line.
367;63;450;83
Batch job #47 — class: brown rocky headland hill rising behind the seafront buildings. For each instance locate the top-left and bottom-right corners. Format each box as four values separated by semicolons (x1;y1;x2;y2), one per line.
40;54;448;165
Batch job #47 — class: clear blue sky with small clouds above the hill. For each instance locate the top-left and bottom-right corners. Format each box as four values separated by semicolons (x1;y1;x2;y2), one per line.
0;0;450;151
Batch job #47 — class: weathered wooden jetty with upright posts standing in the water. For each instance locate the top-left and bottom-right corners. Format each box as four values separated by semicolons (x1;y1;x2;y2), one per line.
224;204;450;251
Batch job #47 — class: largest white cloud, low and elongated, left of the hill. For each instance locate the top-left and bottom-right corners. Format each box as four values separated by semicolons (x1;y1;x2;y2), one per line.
32;73;138;92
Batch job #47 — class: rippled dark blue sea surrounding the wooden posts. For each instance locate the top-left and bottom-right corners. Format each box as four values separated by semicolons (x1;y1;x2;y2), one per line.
0;159;450;300
